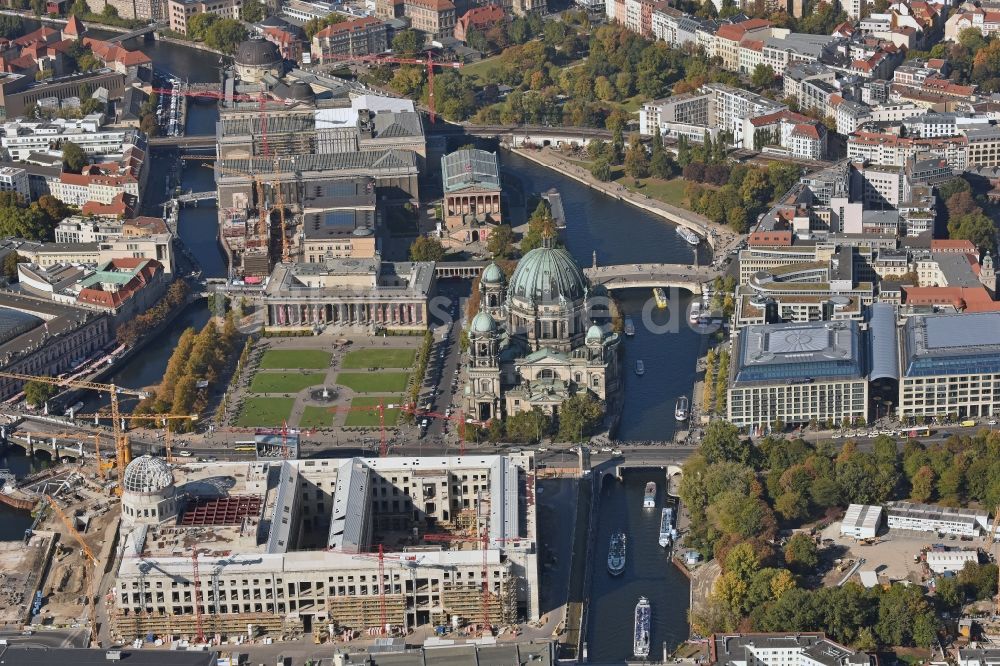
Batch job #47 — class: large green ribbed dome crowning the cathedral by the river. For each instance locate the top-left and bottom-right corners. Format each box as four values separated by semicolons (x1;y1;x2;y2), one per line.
508;240;587;303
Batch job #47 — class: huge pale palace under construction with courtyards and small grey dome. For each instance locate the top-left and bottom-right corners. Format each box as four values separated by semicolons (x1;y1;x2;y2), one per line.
111;454;539;639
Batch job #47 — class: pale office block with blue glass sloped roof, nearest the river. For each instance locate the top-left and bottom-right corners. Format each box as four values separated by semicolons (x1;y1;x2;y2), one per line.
727;321;869;426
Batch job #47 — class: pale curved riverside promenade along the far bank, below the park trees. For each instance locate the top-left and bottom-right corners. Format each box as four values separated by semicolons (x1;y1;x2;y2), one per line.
513;148;745;259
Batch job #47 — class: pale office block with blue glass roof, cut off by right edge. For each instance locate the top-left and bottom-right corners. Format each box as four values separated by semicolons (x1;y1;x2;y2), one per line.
899;312;1000;418
